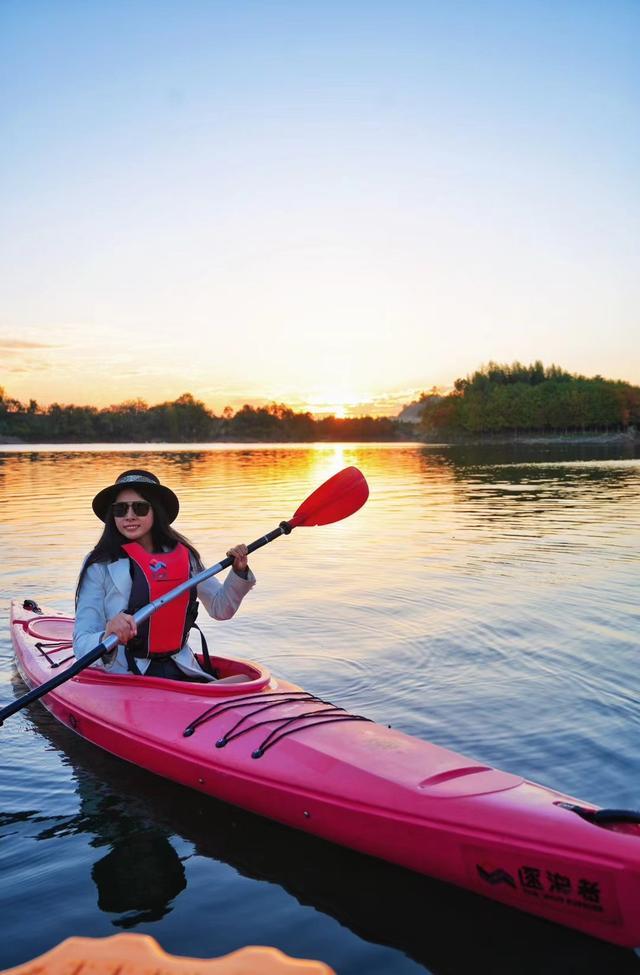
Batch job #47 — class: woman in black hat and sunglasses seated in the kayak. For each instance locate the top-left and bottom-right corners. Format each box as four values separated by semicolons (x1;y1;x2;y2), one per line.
73;470;256;682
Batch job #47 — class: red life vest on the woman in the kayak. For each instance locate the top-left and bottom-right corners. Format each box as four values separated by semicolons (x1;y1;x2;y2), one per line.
122;542;192;659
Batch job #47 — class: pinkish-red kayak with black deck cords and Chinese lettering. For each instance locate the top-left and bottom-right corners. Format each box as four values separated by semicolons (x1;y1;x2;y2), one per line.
11;601;640;947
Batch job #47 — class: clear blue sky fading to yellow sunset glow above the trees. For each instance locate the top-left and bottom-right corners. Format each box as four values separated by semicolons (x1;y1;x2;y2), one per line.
0;0;640;414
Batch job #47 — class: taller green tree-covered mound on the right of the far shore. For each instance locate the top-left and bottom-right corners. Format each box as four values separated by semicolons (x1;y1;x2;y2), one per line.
421;361;640;436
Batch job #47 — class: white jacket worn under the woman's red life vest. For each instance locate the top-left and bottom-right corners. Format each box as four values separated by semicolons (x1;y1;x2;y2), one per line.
73;559;256;680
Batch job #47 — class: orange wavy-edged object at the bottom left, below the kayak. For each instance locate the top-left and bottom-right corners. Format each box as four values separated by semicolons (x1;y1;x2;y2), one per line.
0;934;335;975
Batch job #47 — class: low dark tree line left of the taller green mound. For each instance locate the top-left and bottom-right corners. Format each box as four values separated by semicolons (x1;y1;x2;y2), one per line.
0;387;415;443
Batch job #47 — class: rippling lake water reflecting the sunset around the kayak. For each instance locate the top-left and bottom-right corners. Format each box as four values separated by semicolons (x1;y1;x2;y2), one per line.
0;444;640;975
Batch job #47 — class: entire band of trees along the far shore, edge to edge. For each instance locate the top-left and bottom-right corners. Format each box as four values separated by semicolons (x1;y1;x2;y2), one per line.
0;361;640;443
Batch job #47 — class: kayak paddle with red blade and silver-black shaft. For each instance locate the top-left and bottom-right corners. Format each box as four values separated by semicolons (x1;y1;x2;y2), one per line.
0;467;369;725
